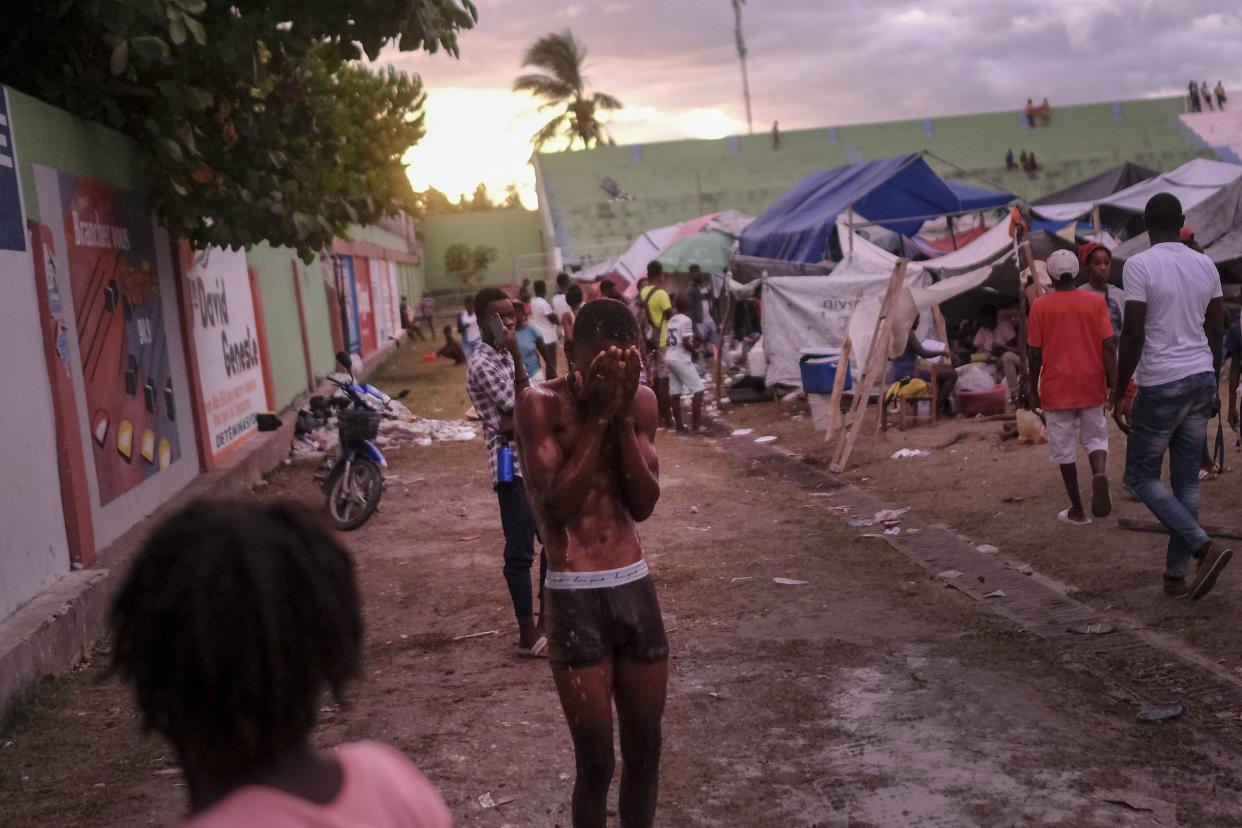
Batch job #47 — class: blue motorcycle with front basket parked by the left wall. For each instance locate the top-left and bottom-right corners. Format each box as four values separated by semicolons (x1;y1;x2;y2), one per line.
323;351;410;531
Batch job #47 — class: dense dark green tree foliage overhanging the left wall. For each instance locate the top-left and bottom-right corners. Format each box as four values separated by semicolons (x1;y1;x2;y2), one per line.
0;0;477;258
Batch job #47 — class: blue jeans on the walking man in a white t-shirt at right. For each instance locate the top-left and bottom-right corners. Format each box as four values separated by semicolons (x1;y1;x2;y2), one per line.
1125;371;1216;578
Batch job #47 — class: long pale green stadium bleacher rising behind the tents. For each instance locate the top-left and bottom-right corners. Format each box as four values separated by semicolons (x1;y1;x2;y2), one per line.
535;98;1213;263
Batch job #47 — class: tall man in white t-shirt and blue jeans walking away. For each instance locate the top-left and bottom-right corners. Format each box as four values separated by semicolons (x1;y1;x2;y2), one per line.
1113;192;1233;598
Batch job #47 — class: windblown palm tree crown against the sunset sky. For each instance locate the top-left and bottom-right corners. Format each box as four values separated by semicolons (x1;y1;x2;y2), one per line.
513;29;621;149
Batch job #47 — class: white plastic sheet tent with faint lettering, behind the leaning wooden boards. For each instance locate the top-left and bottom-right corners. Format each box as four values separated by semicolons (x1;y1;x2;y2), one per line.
763;223;998;386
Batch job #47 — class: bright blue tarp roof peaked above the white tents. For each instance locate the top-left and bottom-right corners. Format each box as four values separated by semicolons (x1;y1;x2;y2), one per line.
739;153;1015;262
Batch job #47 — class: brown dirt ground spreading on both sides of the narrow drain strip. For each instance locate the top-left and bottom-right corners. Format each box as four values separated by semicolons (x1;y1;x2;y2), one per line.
0;349;1242;828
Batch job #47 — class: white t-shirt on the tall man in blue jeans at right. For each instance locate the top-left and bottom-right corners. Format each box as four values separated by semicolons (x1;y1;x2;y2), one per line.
1122;242;1222;386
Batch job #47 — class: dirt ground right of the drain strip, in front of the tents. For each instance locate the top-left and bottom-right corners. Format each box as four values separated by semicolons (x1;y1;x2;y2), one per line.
728;389;1242;674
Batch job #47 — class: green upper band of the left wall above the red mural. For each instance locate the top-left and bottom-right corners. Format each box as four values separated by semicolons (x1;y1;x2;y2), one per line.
6;87;145;221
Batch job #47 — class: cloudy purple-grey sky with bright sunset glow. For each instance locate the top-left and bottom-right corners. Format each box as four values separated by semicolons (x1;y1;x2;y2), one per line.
381;0;1242;206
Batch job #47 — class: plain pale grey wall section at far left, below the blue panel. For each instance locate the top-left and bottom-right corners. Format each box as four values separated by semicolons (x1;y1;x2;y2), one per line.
0;89;70;618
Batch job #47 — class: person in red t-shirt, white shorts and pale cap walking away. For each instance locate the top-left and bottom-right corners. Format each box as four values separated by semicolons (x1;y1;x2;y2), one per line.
1026;250;1117;524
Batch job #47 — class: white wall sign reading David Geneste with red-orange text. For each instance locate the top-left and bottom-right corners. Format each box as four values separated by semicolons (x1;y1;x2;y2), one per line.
181;245;267;466
